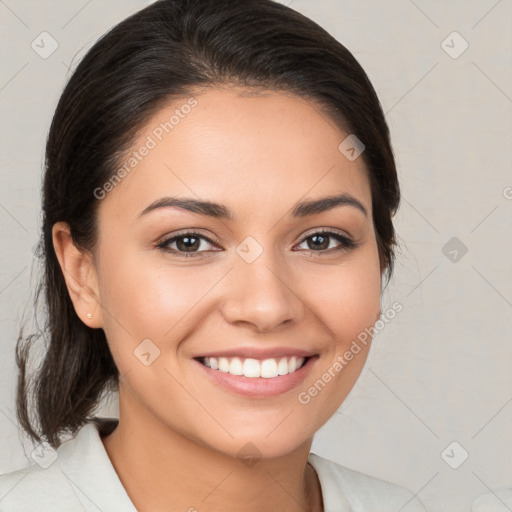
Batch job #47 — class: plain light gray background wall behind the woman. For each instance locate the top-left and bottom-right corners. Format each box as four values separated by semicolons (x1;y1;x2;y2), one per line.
0;0;512;512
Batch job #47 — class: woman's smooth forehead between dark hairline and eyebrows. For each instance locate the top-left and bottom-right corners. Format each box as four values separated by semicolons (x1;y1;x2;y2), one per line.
100;88;371;223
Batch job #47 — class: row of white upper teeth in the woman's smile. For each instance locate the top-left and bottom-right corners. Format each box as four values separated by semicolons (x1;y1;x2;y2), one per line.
202;356;305;379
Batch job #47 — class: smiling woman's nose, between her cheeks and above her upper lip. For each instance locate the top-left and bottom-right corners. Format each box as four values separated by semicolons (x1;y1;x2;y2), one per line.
222;253;305;332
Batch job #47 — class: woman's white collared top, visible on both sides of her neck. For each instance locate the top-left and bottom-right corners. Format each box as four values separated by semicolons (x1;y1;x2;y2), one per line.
0;418;425;512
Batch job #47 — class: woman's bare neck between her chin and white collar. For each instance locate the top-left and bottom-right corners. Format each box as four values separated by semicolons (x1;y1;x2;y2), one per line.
102;394;323;512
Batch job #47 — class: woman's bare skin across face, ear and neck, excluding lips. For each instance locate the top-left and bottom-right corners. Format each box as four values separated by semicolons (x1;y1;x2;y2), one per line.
53;87;381;512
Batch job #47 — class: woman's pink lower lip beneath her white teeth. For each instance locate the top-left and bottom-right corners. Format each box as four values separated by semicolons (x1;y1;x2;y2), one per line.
194;356;318;398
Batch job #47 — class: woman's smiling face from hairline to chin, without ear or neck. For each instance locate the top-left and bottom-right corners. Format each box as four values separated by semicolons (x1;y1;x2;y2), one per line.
91;88;381;457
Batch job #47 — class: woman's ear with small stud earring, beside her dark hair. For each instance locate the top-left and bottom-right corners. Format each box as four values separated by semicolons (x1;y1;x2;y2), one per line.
52;222;103;328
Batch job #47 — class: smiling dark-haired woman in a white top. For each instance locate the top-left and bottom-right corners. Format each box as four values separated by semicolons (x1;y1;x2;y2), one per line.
0;0;424;512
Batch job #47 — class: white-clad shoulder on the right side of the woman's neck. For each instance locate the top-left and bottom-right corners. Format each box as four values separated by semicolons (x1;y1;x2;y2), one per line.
309;453;425;512
